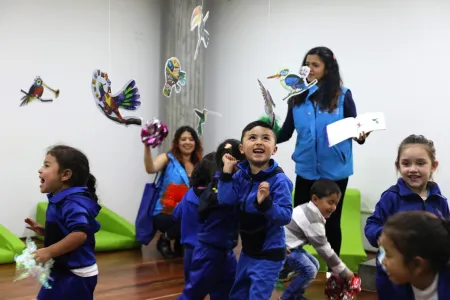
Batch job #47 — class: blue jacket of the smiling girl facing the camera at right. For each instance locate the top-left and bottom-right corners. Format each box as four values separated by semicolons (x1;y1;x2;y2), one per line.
364;178;450;248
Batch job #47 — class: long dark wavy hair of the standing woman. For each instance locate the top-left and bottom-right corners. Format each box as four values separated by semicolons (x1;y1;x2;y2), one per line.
289;47;342;112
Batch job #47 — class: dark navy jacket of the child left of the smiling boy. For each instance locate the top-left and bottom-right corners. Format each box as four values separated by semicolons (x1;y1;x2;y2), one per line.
197;172;239;251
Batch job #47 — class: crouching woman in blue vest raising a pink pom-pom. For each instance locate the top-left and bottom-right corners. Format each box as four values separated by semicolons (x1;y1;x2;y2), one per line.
144;126;203;258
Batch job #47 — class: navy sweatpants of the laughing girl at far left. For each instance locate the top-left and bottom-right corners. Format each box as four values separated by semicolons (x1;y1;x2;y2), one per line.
37;270;97;300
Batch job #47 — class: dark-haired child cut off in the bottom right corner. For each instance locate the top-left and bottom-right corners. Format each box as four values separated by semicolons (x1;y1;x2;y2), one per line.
380;211;450;300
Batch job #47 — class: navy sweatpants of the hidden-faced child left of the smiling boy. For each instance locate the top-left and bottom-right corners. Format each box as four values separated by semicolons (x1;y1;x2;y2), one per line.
178;244;236;300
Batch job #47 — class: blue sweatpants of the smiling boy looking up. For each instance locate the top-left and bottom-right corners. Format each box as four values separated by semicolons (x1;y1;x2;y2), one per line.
229;253;283;300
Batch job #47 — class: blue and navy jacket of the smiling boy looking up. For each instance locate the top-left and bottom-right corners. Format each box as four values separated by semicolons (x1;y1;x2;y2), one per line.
218;159;293;261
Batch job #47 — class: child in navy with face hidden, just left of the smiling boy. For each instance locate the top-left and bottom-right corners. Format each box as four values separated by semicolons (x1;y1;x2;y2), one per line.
178;139;245;300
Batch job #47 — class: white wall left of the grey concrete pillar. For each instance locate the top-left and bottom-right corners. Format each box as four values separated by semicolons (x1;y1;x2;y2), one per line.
0;0;164;236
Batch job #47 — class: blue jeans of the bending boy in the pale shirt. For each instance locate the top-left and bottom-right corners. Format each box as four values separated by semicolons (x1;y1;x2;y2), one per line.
281;248;319;300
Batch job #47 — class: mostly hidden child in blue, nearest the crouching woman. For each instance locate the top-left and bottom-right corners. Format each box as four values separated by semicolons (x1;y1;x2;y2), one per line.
172;152;217;285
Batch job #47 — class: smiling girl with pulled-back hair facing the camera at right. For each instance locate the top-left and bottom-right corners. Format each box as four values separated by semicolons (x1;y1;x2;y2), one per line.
364;135;450;300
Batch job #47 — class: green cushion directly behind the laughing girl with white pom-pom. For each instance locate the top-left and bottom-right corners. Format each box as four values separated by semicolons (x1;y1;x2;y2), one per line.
36;202;140;252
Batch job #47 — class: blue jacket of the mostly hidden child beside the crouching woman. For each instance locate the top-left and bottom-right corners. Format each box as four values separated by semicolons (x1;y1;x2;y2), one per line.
172;188;203;247
